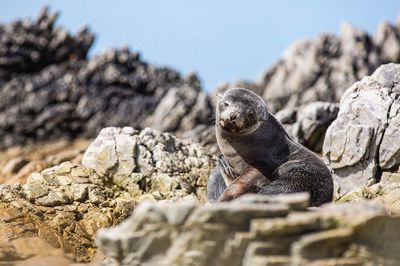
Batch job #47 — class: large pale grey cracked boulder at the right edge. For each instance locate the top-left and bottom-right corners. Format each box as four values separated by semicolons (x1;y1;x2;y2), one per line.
323;64;400;195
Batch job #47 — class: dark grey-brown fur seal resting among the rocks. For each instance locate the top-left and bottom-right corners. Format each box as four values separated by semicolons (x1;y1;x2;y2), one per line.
208;88;333;206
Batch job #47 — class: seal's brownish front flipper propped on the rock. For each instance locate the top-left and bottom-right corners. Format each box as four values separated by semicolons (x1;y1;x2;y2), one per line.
218;167;270;202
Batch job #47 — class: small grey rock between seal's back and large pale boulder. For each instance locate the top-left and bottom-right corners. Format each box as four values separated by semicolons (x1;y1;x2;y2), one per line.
275;102;339;152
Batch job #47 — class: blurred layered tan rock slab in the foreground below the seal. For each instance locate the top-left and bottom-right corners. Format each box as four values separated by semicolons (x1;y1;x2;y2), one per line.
97;194;400;266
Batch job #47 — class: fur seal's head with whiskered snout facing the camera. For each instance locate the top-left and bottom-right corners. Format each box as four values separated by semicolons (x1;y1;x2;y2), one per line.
216;88;268;135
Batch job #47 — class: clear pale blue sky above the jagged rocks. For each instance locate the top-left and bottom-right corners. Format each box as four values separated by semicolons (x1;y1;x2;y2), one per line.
0;0;400;90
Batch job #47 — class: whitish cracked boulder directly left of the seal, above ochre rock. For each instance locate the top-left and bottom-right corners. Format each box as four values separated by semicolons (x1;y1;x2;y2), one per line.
82;127;214;201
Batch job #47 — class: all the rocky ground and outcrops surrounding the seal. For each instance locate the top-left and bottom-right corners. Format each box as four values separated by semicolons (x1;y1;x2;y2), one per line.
0;5;400;265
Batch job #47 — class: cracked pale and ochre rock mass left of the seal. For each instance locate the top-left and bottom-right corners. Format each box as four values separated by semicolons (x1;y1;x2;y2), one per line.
0;128;214;262
